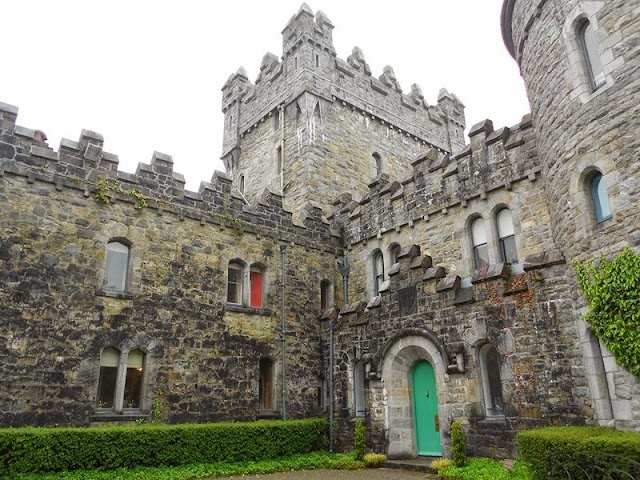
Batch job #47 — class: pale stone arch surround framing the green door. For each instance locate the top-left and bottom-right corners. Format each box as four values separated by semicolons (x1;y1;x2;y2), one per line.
381;334;448;458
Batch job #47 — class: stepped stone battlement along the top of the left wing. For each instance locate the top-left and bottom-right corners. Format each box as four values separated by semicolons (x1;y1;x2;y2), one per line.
0;103;339;253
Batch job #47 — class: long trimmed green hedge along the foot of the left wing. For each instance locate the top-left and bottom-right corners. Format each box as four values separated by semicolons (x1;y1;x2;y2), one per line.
0;419;328;473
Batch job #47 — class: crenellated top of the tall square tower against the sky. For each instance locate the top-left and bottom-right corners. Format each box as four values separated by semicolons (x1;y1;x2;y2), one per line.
222;4;465;163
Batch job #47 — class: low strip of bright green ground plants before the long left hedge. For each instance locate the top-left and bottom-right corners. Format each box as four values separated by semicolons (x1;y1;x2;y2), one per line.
11;452;363;480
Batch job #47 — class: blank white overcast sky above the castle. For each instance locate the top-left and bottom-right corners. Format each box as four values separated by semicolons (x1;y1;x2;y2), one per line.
0;0;529;191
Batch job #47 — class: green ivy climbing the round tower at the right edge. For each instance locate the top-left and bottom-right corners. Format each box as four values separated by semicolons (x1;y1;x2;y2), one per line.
574;248;640;378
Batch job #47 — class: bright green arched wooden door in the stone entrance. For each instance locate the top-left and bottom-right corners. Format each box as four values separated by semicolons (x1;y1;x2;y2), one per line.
412;360;442;456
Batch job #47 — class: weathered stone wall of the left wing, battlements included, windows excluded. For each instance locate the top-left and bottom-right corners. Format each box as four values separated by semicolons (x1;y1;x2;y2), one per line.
0;104;341;426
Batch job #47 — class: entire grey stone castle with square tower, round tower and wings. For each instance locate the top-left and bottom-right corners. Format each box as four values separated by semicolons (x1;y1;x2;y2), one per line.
0;0;640;457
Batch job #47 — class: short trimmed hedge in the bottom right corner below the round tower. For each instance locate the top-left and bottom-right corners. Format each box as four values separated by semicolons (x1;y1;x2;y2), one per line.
516;426;640;480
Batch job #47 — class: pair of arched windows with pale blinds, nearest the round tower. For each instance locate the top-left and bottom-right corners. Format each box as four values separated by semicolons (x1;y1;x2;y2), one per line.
471;208;518;269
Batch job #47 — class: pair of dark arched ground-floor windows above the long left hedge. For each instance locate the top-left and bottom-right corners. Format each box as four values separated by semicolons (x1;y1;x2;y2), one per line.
96;347;145;412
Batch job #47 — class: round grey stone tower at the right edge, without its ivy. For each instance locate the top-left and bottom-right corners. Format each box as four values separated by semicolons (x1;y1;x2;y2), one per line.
502;0;640;429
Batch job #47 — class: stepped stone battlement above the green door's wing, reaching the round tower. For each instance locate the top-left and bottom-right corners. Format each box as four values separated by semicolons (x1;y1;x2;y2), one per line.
330;115;542;248
